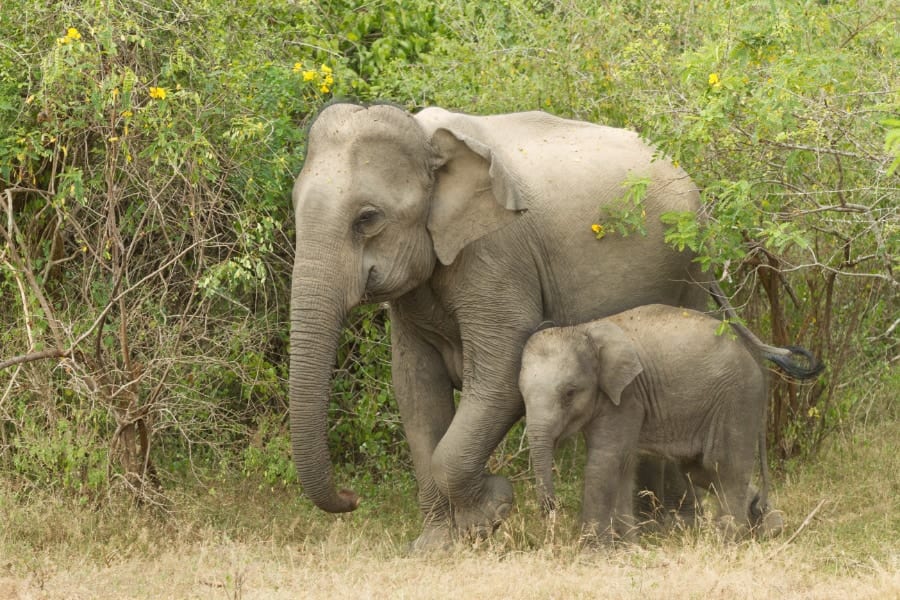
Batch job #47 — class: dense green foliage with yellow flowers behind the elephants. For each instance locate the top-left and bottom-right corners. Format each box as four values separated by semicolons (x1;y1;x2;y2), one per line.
0;0;900;498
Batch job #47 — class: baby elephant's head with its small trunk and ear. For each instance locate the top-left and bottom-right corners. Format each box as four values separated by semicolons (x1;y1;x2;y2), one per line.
519;320;643;509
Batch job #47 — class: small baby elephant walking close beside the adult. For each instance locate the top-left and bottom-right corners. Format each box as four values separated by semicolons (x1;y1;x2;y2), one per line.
519;305;821;542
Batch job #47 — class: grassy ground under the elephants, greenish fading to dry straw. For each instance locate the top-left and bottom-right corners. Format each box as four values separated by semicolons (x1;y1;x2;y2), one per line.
0;377;900;599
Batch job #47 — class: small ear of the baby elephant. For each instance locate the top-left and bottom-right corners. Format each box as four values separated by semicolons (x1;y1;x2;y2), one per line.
585;319;644;406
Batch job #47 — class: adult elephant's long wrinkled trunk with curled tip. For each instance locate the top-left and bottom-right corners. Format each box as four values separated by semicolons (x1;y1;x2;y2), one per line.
289;258;359;513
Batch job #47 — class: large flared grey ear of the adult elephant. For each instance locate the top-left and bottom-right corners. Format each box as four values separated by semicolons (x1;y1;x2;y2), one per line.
428;127;527;265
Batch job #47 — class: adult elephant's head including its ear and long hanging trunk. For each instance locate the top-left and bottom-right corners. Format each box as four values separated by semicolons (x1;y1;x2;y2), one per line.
289;104;525;512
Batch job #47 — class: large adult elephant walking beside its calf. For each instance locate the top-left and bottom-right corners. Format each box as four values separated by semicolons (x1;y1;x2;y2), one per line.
290;104;707;548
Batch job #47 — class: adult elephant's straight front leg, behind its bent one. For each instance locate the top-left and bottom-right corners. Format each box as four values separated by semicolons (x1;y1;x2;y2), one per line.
391;311;454;552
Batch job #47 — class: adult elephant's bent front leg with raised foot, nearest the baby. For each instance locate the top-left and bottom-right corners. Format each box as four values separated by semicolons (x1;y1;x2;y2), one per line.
431;282;543;536
